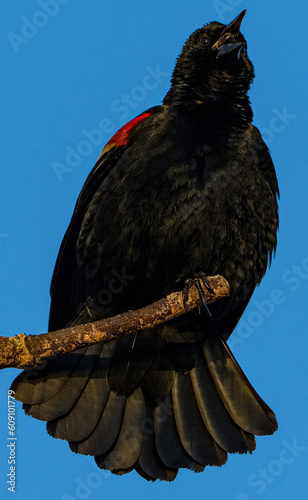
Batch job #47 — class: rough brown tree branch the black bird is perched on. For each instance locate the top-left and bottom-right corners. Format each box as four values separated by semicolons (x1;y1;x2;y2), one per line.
0;276;230;369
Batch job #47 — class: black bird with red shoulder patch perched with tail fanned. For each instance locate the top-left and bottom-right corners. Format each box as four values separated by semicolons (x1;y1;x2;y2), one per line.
12;11;278;481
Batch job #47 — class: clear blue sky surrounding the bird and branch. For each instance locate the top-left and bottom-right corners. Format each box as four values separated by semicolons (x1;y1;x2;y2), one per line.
0;0;308;500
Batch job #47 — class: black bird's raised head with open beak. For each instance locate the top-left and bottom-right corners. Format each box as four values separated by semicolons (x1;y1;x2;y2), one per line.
164;10;254;115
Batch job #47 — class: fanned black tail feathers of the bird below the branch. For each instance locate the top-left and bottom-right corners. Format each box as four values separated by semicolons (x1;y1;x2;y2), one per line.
12;333;277;481
